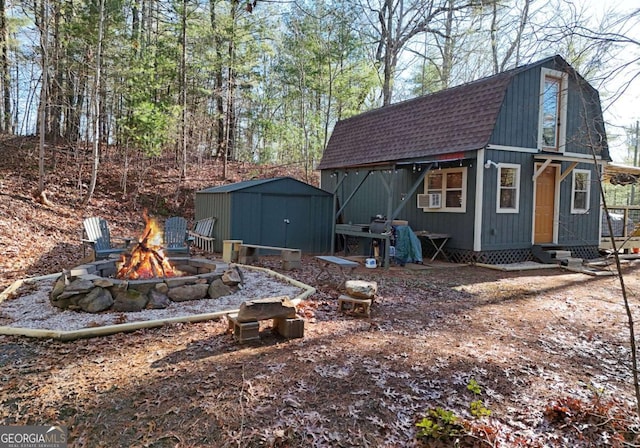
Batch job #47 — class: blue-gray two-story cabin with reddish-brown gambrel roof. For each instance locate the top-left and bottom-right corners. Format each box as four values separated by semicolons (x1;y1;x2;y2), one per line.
318;56;610;264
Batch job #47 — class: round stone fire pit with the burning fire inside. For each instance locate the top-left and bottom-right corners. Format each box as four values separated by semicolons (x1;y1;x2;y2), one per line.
50;214;242;313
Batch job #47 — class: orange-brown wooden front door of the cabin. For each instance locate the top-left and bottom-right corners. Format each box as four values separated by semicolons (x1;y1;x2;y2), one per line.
533;165;557;244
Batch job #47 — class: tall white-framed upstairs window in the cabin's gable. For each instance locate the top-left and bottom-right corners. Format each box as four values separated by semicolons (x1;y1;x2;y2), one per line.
538;69;567;152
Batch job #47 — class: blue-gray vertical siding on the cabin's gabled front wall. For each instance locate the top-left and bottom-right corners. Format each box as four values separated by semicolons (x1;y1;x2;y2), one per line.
482;57;605;250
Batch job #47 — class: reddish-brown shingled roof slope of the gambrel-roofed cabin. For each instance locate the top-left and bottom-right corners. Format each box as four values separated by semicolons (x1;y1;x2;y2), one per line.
318;66;524;169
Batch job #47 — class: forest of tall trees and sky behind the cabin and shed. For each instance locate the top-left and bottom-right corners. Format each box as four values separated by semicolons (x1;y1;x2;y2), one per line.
0;0;640;198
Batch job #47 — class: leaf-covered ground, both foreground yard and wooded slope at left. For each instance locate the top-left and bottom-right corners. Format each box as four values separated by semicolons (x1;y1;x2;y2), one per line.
0;140;640;447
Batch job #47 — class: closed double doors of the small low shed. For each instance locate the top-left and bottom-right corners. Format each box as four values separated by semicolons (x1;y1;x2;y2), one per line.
261;194;311;249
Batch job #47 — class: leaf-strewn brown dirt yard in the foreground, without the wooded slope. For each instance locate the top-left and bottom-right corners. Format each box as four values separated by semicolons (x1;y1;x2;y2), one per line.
0;257;638;447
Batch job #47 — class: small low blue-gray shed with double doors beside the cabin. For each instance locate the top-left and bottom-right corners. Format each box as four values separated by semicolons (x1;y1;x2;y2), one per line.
195;177;333;253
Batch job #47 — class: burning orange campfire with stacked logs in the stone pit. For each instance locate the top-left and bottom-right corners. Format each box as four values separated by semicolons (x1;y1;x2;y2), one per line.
116;210;182;280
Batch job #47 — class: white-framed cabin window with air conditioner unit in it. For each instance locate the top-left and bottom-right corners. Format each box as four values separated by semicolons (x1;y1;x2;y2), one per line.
423;167;467;213
